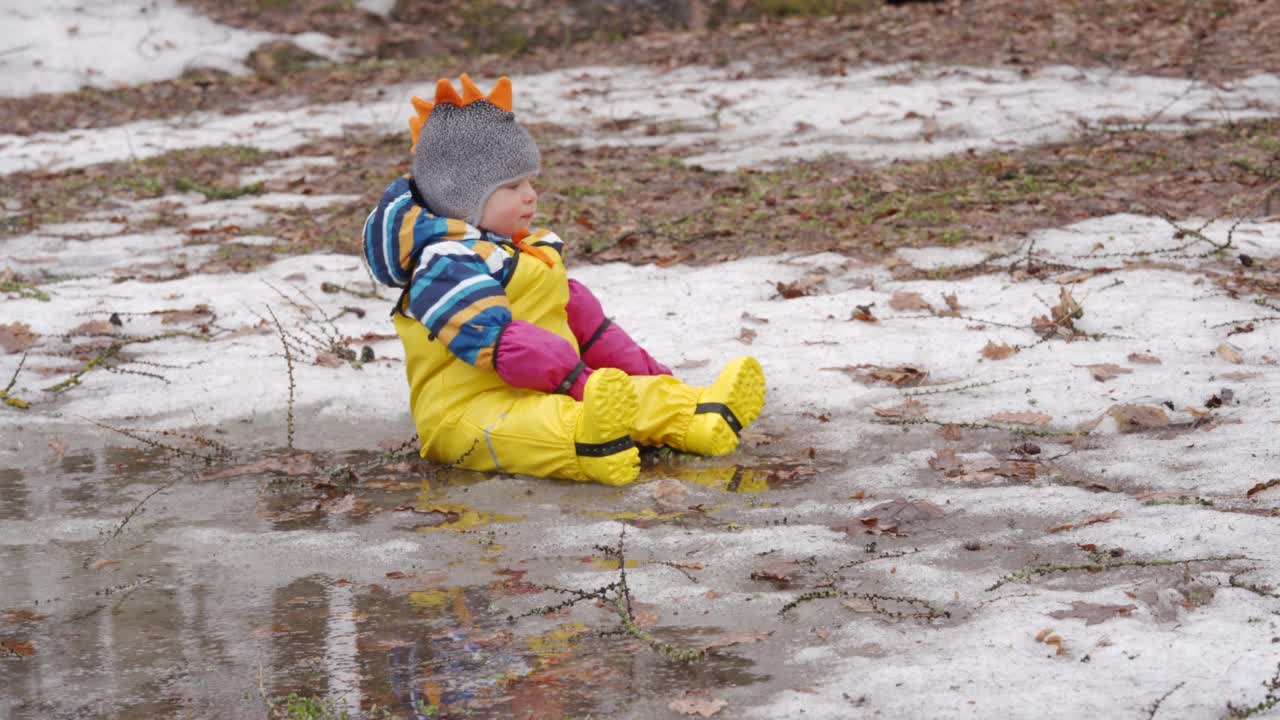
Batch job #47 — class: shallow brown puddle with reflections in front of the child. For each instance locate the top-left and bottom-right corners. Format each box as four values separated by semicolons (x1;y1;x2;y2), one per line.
0;440;769;719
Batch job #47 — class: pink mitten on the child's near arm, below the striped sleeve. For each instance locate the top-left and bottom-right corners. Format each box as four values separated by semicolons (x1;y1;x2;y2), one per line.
493;320;591;401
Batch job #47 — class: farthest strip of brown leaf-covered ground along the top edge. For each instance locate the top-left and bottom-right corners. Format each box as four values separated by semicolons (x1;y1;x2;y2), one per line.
0;0;1280;135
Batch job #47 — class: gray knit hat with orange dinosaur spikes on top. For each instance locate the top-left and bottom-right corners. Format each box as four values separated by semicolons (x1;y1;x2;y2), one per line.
410;73;541;225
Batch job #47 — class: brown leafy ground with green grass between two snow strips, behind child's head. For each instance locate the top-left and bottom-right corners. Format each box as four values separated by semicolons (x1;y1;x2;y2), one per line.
0;114;1280;272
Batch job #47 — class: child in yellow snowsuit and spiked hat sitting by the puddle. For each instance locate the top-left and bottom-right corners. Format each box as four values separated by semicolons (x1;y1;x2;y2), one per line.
365;74;764;486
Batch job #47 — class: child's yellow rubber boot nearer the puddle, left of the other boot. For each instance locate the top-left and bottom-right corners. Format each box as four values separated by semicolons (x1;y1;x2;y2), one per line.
573;368;640;486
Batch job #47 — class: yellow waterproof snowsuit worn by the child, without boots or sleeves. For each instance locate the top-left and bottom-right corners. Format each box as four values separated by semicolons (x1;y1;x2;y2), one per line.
393;233;701;480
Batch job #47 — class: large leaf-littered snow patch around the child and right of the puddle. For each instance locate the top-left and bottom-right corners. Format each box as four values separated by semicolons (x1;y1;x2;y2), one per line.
0;208;1280;717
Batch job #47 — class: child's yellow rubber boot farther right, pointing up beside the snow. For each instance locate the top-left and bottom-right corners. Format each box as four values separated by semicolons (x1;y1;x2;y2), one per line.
680;356;764;455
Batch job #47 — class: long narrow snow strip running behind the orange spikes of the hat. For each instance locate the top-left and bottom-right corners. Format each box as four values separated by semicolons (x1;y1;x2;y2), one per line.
0;64;1280;173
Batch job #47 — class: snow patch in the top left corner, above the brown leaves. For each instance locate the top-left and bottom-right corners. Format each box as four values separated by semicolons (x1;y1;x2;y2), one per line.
0;0;343;97
